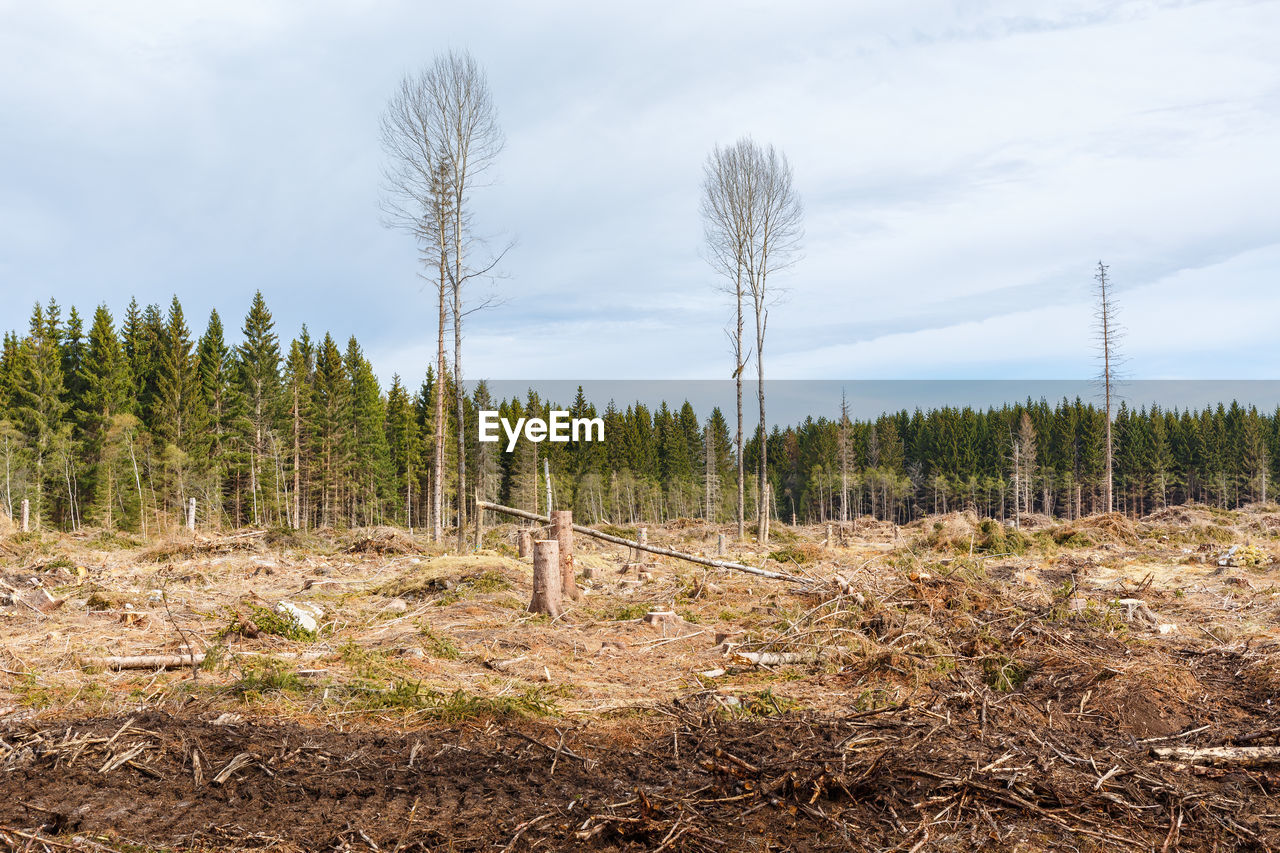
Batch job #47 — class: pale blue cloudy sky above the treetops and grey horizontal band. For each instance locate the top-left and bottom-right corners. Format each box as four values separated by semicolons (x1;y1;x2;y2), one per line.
0;0;1280;384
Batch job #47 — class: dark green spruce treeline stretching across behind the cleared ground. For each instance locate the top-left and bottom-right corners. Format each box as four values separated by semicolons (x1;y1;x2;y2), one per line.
0;293;1280;533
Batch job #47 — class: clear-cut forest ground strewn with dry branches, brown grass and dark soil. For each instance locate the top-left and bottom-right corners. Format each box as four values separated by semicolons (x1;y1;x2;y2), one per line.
0;507;1280;853
